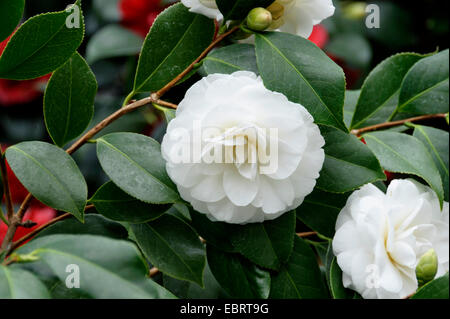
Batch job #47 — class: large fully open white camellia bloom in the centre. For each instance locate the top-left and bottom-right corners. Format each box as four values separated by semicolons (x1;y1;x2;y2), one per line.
162;71;325;224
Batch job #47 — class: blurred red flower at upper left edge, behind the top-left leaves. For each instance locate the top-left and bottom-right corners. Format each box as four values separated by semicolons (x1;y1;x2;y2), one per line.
0;34;50;106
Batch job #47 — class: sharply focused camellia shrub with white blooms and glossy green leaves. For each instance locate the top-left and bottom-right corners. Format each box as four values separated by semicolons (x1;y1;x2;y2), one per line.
0;0;449;299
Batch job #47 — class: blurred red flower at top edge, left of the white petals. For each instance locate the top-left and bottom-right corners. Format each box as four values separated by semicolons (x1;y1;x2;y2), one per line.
119;0;165;37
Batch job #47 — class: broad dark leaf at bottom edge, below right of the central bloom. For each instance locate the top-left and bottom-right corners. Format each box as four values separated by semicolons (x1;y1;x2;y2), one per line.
270;237;328;299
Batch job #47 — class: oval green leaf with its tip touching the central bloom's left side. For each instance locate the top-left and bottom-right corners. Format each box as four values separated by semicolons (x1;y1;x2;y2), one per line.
97;133;180;204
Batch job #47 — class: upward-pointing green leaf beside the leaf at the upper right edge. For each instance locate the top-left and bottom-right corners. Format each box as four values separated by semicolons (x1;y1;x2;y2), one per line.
351;53;423;129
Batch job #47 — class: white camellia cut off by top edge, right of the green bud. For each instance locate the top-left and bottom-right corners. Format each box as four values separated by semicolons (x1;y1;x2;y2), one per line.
269;0;335;38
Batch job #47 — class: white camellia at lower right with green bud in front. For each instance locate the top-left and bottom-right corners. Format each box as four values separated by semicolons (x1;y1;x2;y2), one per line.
333;179;449;299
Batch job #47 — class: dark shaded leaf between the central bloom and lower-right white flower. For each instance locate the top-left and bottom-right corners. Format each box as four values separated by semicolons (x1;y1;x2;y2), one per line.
297;188;350;239
